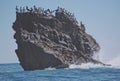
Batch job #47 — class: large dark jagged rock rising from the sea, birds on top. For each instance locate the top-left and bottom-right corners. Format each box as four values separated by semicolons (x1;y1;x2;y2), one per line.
13;7;101;70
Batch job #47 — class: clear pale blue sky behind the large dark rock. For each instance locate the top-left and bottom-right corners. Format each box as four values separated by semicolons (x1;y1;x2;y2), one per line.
0;0;120;63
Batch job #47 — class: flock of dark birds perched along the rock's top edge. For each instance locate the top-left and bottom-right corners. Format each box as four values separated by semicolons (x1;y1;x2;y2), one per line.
16;6;78;24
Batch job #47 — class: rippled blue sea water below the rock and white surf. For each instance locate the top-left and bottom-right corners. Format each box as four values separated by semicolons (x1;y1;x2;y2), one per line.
0;64;120;81
